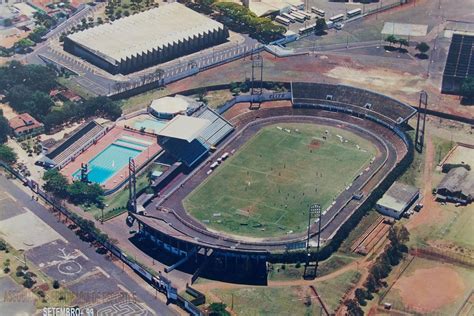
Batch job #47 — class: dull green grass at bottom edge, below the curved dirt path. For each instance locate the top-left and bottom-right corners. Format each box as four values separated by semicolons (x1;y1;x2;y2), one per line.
211;286;319;316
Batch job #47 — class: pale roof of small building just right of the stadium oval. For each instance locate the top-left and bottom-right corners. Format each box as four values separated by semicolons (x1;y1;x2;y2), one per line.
377;182;418;212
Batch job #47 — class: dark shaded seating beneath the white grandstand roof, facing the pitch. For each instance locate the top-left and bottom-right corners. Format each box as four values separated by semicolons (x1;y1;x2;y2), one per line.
158;137;209;167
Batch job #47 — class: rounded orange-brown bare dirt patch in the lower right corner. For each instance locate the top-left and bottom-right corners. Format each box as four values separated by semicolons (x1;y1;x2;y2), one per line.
394;267;465;312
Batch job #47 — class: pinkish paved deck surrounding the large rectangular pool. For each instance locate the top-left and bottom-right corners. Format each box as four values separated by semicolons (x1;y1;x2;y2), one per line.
61;126;161;190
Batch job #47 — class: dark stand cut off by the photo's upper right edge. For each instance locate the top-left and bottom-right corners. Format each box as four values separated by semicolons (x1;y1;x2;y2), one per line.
441;34;474;94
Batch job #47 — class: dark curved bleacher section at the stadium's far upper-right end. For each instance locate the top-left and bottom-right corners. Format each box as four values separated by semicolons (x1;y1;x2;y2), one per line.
292;82;416;124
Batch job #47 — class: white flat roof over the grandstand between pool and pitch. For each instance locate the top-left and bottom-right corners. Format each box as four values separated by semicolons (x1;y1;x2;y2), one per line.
158;115;211;143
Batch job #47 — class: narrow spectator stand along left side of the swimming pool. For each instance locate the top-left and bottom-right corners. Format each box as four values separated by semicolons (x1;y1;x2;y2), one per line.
38;121;107;169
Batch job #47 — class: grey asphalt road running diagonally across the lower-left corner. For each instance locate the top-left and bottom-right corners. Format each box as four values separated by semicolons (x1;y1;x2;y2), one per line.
0;175;178;315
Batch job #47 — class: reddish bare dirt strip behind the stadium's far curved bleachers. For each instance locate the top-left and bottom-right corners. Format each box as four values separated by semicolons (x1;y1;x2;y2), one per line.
162;51;474;117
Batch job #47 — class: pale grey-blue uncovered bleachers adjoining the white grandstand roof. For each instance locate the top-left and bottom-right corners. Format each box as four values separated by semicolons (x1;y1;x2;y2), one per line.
193;106;234;146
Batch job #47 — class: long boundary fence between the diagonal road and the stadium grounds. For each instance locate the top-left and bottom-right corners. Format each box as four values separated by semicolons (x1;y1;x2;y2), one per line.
0;161;202;315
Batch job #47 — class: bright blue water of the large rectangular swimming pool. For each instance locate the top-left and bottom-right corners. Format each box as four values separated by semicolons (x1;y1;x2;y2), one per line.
72;143;142;184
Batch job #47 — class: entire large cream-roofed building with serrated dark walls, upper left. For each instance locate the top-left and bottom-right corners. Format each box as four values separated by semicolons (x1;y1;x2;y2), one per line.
64;2;229;74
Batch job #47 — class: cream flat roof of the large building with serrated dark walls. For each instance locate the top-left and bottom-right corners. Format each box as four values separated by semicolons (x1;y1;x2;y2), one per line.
68;2;224;62
